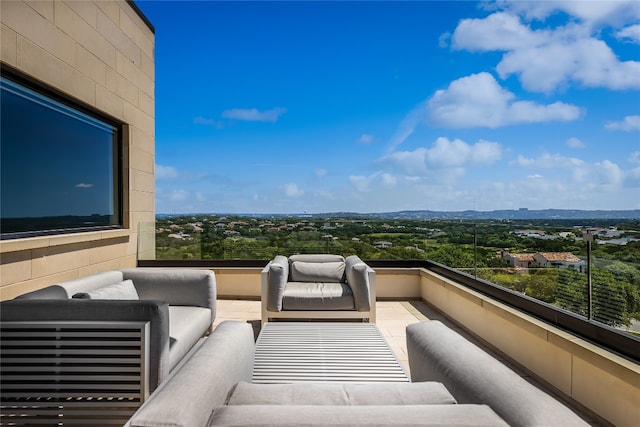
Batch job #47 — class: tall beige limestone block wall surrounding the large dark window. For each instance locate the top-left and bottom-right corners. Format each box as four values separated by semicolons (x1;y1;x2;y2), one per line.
0;0;155;300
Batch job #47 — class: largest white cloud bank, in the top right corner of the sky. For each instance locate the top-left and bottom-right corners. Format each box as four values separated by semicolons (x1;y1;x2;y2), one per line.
453;8;640;93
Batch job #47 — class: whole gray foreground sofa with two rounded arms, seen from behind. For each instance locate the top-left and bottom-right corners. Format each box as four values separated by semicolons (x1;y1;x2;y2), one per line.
126;321;588;427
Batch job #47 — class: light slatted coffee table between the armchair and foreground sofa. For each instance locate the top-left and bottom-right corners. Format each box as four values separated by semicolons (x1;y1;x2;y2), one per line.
253;322;409;383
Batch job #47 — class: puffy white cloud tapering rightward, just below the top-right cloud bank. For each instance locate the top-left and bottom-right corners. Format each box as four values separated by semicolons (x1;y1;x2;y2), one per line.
428;72;581;128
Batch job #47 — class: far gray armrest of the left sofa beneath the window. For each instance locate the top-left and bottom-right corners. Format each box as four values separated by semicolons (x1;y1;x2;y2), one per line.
122;268;216;323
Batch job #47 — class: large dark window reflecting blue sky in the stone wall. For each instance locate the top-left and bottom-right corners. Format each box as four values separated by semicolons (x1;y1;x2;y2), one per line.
0;76;123;239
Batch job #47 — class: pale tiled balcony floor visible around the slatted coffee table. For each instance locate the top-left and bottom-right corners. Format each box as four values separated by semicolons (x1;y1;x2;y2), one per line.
214;299;610;426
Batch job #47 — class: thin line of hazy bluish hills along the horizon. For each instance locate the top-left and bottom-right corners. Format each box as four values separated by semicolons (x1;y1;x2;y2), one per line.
157;209;640;220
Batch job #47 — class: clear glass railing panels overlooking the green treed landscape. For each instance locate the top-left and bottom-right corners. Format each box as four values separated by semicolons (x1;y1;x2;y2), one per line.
139;215;640;335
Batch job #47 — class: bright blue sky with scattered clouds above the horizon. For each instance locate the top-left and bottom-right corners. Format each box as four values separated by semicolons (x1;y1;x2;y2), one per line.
137;0;640;213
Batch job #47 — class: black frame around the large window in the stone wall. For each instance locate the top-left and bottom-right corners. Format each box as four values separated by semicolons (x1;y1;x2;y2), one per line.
0;67;128;241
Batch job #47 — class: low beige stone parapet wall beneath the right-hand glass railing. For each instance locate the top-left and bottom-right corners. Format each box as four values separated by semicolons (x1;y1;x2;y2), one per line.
421;270;640;426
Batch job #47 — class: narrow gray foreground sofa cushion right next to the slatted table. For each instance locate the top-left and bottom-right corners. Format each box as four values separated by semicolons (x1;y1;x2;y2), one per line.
229;382;456;406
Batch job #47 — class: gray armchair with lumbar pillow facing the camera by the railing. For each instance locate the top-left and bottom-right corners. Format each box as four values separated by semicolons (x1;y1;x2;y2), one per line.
262;254;375;322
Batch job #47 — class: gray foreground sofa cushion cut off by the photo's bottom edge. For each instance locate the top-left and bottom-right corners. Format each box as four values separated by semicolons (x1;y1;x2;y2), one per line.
211;405;508;427
